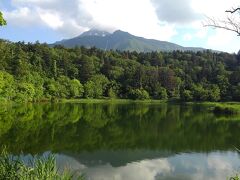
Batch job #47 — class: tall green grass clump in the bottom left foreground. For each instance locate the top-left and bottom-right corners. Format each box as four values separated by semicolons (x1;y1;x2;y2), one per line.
0;151;84;180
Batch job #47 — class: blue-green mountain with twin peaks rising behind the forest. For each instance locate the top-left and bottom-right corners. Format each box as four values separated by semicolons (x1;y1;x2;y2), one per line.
52;29;204;52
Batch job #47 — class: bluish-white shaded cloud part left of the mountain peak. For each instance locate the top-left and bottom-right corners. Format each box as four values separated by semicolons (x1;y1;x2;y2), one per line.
4;0;95;38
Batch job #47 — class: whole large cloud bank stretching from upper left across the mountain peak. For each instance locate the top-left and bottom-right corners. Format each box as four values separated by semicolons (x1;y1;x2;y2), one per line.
2;0;177;40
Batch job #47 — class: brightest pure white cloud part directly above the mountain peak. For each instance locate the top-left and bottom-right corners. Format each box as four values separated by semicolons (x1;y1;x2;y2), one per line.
83;0;176;40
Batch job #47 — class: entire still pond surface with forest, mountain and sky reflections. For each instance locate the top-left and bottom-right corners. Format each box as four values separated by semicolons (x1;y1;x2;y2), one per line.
0;103;240;180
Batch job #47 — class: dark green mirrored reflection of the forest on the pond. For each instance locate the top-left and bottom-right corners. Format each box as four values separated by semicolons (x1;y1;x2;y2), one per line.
0;104;240;153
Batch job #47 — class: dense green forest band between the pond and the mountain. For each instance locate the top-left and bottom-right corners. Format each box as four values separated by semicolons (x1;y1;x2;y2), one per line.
0;40;240;102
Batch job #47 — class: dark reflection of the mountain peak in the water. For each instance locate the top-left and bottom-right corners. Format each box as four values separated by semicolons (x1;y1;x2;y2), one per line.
62;149;174;167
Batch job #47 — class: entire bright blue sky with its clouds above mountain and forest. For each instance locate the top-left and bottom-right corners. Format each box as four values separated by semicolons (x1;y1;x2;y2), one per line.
0;0;240;53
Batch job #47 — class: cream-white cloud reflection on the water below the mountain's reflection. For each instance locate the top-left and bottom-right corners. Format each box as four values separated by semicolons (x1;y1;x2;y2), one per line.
57;155;174;180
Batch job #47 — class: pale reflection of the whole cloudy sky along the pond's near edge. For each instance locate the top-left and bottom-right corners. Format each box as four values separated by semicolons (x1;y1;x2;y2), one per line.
54;152;240;180
